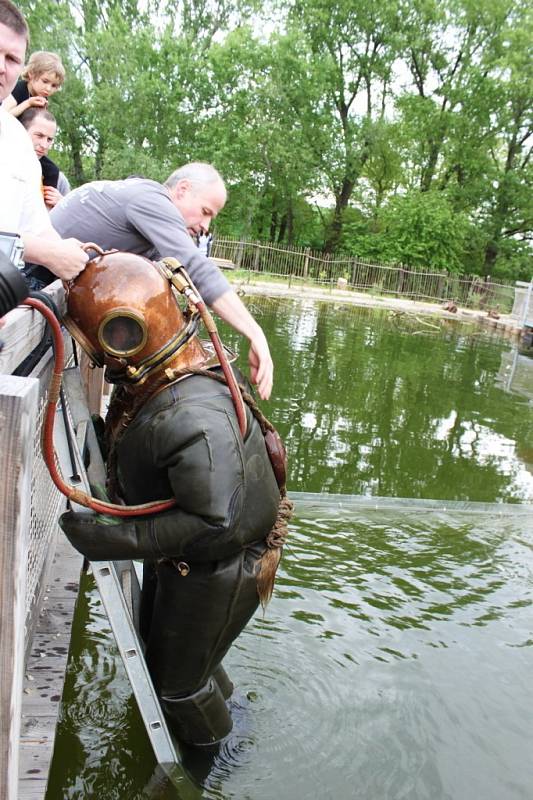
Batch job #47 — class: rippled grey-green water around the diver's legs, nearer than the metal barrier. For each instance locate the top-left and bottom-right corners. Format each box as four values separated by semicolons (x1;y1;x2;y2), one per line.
48;504;533;800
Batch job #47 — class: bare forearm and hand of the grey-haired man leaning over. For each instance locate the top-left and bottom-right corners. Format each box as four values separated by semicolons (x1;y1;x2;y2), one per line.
212;289;274;400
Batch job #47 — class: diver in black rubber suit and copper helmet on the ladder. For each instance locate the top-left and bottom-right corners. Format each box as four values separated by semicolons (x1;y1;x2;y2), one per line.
60;248;290;745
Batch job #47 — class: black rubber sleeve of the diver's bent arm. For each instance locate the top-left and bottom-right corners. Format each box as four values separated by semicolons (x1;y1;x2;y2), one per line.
60;409;249;561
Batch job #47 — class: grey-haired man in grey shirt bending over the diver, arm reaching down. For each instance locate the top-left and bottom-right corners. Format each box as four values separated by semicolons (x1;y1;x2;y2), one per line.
50;162;274;400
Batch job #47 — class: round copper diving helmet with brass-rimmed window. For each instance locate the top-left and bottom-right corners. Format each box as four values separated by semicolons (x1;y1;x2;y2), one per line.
64;251;224;384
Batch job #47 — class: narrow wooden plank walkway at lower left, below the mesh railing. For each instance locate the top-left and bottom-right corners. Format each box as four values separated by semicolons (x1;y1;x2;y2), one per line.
18;531;83;800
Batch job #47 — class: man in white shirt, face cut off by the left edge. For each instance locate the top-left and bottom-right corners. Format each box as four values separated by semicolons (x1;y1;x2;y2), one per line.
0;0;88;280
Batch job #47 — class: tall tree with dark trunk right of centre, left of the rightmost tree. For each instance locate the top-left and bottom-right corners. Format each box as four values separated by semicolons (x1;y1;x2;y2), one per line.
286;0;399;252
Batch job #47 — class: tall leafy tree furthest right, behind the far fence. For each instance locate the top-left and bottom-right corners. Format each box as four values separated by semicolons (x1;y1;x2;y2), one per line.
398;0;533;275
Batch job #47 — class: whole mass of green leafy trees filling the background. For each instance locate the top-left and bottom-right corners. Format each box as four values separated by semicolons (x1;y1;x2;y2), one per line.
14;0;533;280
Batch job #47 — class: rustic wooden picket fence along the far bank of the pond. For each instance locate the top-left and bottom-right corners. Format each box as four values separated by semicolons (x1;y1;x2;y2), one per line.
211;238;514;314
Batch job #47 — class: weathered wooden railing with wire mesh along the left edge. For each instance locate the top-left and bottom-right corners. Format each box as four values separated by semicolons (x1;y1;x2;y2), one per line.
0;283;71;800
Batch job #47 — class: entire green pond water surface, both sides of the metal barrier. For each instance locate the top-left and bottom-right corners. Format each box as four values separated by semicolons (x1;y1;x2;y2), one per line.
47;298;533;800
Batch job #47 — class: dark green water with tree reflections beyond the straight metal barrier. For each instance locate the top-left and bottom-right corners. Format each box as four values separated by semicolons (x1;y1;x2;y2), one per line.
248;300;533;502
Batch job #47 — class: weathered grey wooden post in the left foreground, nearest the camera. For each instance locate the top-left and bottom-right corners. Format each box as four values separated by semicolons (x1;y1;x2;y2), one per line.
0;375;39;800
